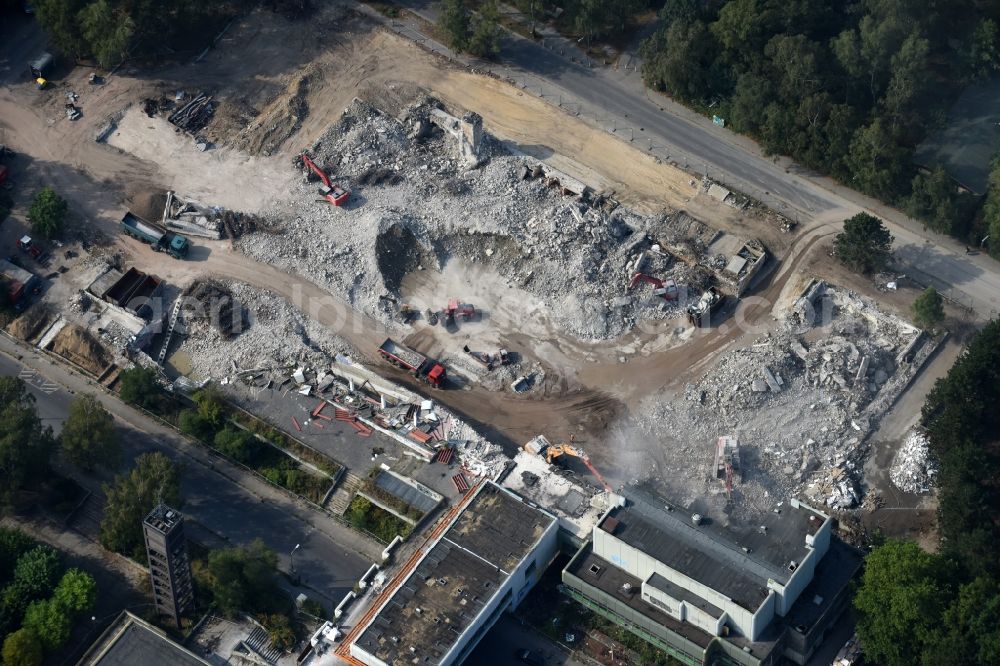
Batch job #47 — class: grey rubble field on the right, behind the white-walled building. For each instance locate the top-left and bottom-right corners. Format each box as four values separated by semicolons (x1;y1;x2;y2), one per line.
619;282;936;514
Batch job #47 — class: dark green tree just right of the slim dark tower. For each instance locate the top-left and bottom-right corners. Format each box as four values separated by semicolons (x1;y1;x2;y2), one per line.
199;539;289;617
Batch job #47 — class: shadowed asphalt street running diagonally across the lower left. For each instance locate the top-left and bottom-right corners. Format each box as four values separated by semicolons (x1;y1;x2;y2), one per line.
0;344;377;602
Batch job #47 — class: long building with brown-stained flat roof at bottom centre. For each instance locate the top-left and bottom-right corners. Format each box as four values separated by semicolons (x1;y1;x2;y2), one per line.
350;481;559;666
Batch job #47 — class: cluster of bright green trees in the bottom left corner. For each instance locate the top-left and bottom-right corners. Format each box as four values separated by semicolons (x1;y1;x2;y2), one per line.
0;528;97;666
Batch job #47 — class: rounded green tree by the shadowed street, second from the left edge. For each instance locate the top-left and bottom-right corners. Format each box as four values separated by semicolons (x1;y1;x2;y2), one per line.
59;394;122;470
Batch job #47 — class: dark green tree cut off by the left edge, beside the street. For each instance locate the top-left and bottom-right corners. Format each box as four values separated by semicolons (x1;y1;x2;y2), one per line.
0;377;54;503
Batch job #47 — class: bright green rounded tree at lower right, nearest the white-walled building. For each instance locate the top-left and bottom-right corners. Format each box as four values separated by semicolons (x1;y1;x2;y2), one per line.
854;540;952;666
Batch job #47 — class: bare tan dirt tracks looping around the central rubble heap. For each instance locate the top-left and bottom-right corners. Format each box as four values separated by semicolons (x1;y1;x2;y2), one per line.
0;8;813;452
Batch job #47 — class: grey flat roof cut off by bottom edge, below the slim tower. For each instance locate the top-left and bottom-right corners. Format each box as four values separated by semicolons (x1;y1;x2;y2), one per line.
77;611;210;666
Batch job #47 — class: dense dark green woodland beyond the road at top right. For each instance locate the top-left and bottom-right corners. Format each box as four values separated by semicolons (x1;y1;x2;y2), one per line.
643;0;1000;236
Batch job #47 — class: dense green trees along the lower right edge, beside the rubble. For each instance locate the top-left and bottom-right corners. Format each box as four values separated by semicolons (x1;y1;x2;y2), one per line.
855;321;1000;666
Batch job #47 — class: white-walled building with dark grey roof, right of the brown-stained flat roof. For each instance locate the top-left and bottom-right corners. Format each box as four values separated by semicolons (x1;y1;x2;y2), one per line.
562;495;861;666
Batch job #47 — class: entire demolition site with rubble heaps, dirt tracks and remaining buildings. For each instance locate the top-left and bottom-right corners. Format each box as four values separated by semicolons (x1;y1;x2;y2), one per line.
0;8;947;665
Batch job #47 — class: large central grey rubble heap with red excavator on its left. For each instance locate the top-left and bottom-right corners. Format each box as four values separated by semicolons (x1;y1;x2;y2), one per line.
238;100;740;339
